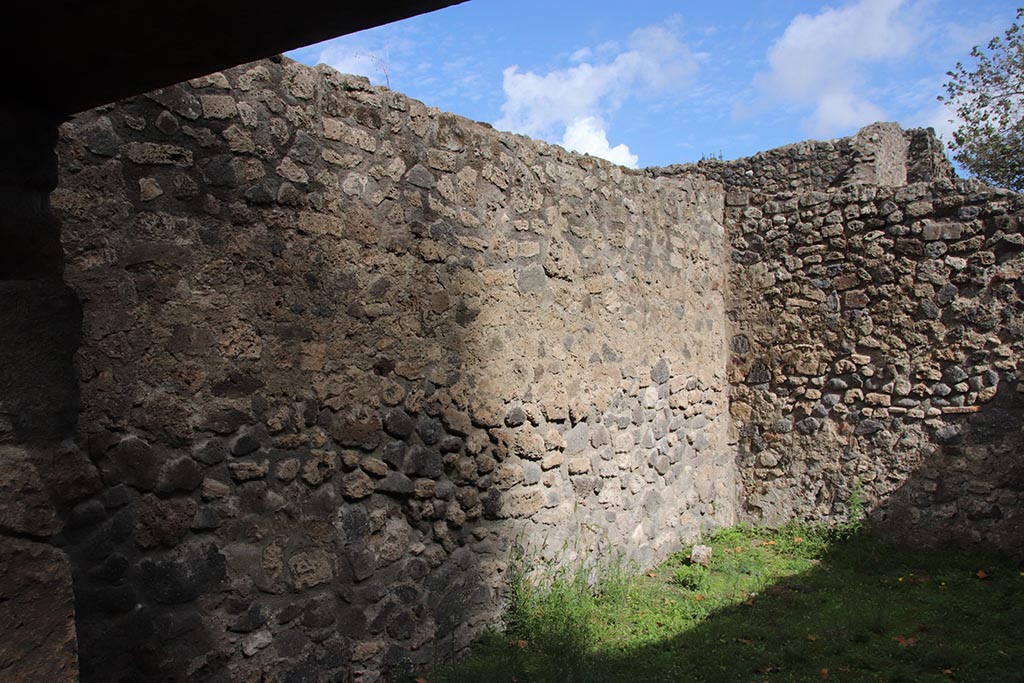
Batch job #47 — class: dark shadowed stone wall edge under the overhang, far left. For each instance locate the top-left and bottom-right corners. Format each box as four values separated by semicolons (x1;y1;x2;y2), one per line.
0;109;81;683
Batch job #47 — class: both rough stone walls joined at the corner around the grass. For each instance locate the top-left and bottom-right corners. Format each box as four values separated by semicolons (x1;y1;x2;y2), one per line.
46;52;1024;682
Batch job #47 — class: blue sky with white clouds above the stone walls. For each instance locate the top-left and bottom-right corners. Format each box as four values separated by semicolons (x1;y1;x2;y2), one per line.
289;0;1020;167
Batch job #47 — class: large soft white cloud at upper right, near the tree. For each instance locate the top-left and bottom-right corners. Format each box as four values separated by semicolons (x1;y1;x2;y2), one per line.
755;0;919;136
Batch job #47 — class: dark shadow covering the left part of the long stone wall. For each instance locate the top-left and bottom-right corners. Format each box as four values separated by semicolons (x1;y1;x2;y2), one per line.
55;70;504;683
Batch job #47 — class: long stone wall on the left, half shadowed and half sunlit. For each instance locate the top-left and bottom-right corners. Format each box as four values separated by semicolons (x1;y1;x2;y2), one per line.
53;59;736;681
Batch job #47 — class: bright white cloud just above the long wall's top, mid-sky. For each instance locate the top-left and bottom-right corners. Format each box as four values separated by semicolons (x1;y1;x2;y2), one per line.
495;19;697;166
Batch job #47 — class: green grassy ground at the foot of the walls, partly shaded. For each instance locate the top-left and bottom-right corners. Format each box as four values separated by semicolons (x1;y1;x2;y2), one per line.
411;524;1024;683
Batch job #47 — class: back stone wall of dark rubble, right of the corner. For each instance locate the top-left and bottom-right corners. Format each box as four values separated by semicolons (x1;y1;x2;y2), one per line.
671;150;1024;549
